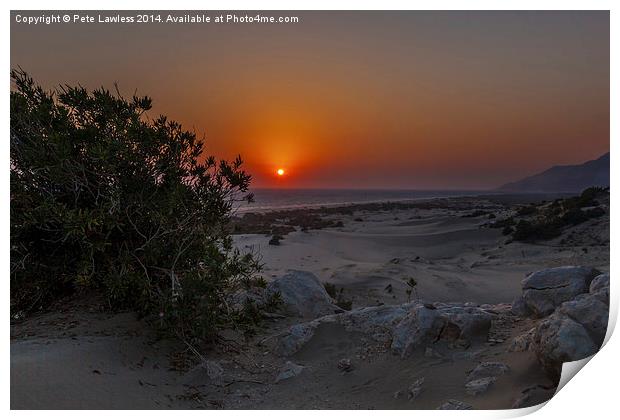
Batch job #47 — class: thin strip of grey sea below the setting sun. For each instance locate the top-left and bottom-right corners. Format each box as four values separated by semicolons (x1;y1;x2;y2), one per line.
232;188;489;213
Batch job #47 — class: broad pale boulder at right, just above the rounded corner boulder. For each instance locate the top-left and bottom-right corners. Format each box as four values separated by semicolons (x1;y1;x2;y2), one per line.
521;266;600;318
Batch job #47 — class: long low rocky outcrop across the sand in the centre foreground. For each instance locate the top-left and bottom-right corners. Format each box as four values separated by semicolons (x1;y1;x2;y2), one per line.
277;303;496;357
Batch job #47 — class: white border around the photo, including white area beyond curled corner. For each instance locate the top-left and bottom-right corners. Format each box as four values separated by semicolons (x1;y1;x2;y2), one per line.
0;0;620;420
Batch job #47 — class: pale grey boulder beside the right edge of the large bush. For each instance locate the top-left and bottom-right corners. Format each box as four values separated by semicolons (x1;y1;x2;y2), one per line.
265;271;338;318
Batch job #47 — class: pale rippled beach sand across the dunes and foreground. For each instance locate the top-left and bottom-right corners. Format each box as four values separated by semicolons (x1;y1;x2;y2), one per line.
11;198;609;409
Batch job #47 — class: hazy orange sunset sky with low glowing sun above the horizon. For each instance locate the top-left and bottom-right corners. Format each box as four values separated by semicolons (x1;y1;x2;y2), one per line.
10;11;610;189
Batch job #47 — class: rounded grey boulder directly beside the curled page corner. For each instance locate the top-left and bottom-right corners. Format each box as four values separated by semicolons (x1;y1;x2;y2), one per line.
533;315;598;379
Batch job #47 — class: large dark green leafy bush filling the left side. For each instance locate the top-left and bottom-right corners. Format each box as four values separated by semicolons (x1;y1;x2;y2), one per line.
10;70;260;338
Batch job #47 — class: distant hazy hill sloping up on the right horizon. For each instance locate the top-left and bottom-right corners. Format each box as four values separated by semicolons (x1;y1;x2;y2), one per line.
498;153;609;192
